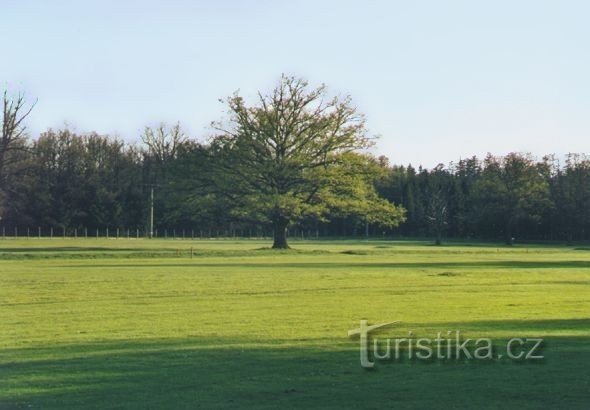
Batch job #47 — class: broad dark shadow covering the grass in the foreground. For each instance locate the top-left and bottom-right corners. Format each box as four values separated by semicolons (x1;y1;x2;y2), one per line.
0;319;590;409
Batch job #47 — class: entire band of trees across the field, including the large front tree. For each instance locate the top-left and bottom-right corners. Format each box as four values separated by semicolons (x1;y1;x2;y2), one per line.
0;81;590;247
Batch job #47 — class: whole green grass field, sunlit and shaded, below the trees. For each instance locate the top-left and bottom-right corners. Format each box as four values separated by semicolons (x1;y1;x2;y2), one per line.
0;239;590;409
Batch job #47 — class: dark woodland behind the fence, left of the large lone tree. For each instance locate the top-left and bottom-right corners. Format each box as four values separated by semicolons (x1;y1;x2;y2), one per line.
0;125;384;236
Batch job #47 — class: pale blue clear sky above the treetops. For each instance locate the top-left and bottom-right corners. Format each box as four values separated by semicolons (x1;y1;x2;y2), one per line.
0;0;590;167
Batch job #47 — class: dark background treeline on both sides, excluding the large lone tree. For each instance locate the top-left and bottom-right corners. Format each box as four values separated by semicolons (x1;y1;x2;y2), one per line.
0;126;590;241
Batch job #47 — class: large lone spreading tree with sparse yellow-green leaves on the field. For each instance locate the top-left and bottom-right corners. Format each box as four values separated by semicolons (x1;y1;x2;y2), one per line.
213;76;403;249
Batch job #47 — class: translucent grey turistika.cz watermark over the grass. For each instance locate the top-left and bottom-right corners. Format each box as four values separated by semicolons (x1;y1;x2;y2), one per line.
348;320;545;369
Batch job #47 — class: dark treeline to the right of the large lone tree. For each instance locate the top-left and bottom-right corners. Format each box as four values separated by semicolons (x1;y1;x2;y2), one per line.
376;153;590;243
